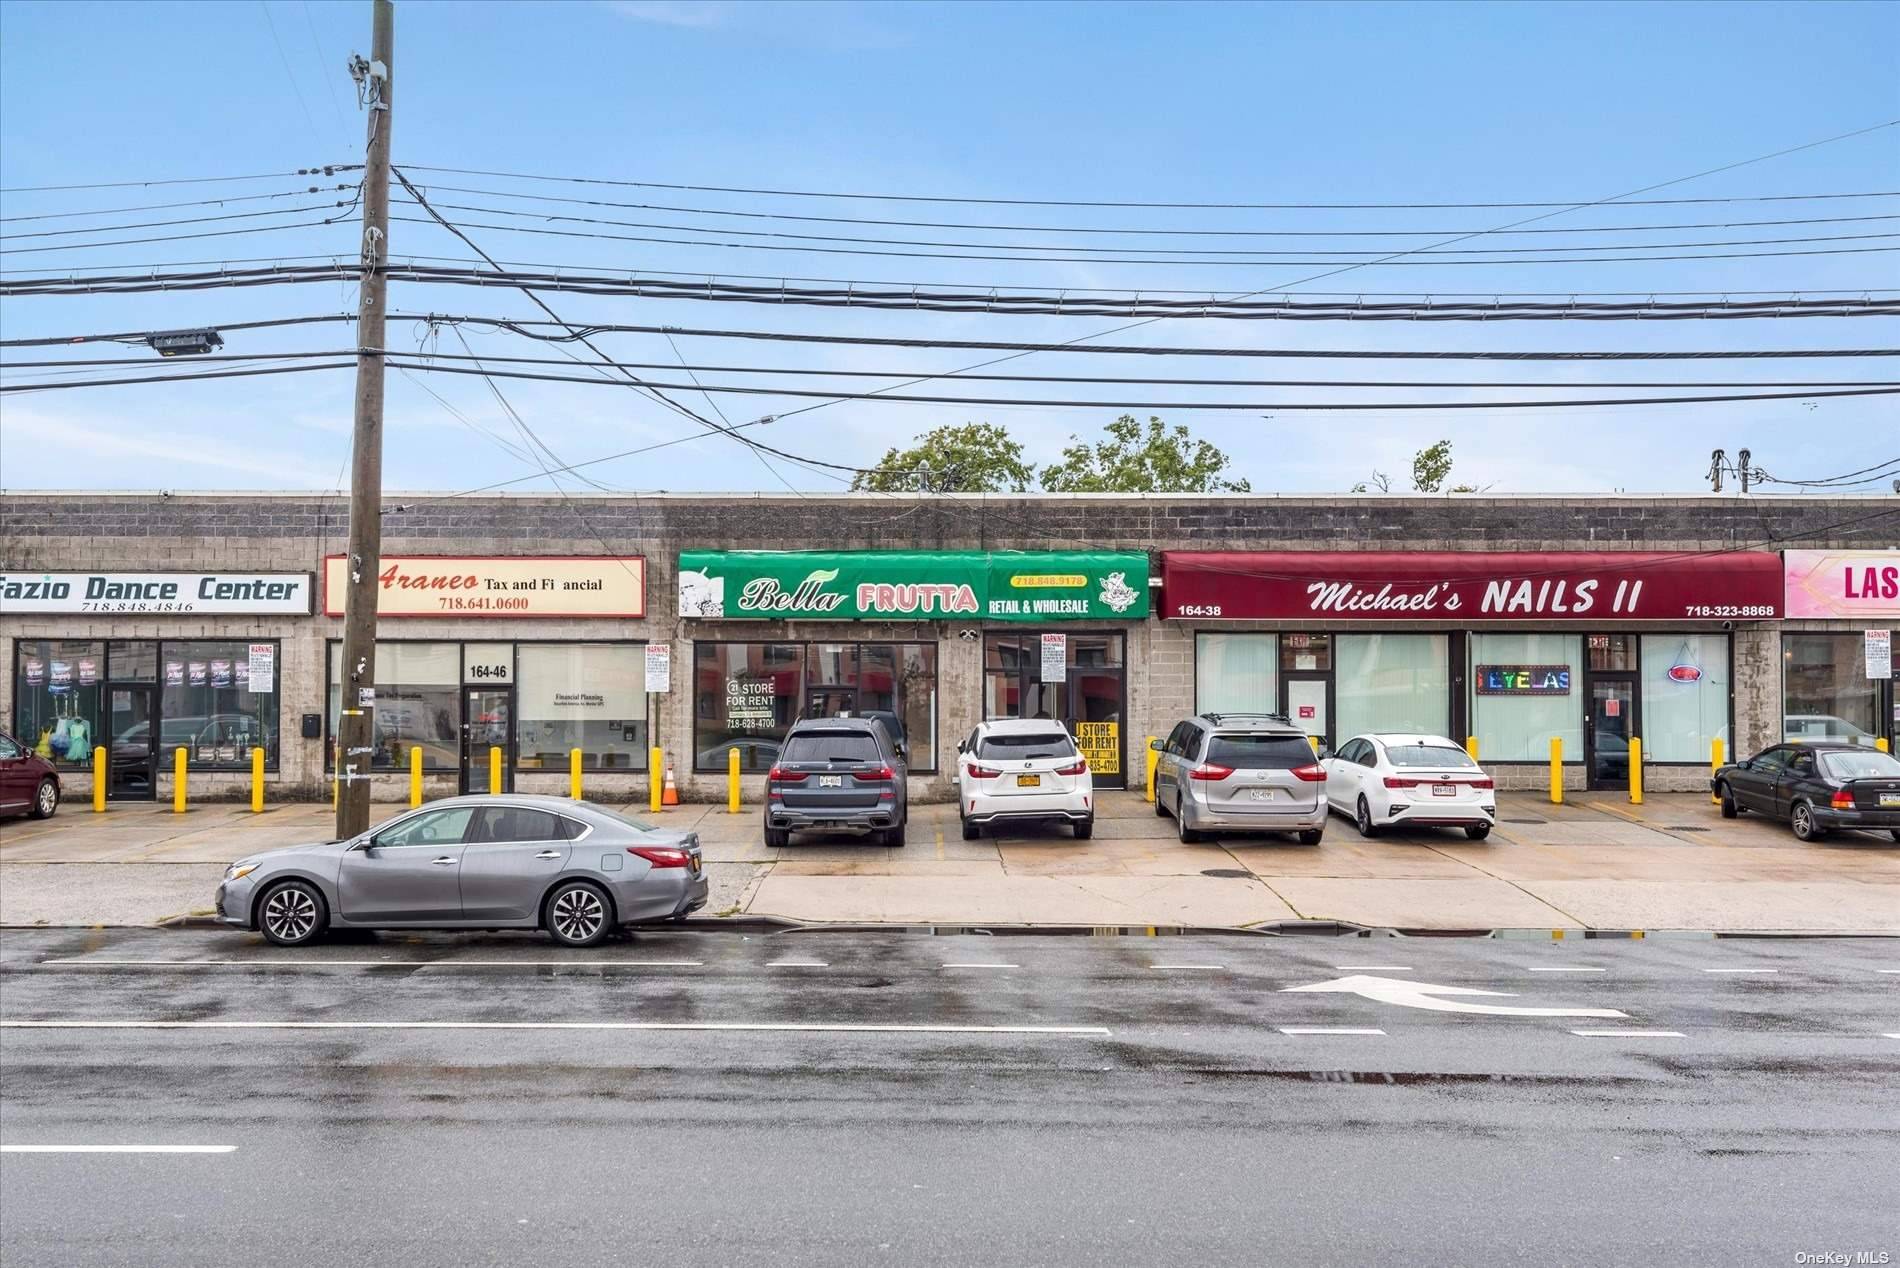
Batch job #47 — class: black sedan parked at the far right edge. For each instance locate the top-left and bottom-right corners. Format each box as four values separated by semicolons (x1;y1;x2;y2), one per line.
1708;743;1900;840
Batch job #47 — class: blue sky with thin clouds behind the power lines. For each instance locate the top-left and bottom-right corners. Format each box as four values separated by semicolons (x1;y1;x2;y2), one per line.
0;0;1900;492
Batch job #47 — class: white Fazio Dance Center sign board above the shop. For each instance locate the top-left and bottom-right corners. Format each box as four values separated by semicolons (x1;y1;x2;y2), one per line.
0;570;312;616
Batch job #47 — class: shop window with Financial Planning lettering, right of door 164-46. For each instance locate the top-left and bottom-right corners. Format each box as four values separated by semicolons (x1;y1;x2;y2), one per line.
515;643;648;770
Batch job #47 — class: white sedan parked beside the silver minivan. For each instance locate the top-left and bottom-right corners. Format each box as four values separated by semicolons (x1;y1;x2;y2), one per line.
1321;732;1497;840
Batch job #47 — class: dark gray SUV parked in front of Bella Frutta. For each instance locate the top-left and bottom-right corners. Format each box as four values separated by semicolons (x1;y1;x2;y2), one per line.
766;719;910;846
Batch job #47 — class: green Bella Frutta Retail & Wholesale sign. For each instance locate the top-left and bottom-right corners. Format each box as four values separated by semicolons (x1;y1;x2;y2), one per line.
680;551;1148;622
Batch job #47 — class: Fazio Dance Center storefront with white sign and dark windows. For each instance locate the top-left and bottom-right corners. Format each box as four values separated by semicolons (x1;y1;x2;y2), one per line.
0;572;312;800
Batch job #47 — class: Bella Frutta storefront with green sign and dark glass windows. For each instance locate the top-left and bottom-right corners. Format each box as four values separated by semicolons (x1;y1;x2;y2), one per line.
678;551;1150;785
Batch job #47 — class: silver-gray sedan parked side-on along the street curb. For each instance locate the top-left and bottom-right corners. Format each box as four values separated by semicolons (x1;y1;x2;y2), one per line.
217;795;707;947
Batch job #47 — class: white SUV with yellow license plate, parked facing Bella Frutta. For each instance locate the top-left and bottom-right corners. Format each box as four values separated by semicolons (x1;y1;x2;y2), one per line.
956;719;1094;840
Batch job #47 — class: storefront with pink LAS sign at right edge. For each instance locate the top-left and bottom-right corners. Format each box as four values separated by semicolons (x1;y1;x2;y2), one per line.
1780;549;1900;747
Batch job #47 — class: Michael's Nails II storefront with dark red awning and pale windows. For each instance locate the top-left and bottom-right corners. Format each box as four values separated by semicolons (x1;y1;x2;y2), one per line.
1163;551;1780;789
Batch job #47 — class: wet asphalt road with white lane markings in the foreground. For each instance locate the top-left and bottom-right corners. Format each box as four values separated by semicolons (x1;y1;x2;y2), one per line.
0;930;1900;1268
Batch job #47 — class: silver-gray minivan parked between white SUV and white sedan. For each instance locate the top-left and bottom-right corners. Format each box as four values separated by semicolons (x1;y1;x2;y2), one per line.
1155;713;1326;846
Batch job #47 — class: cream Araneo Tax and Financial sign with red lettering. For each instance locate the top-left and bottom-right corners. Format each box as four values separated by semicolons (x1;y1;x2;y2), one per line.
323;555;646;618
